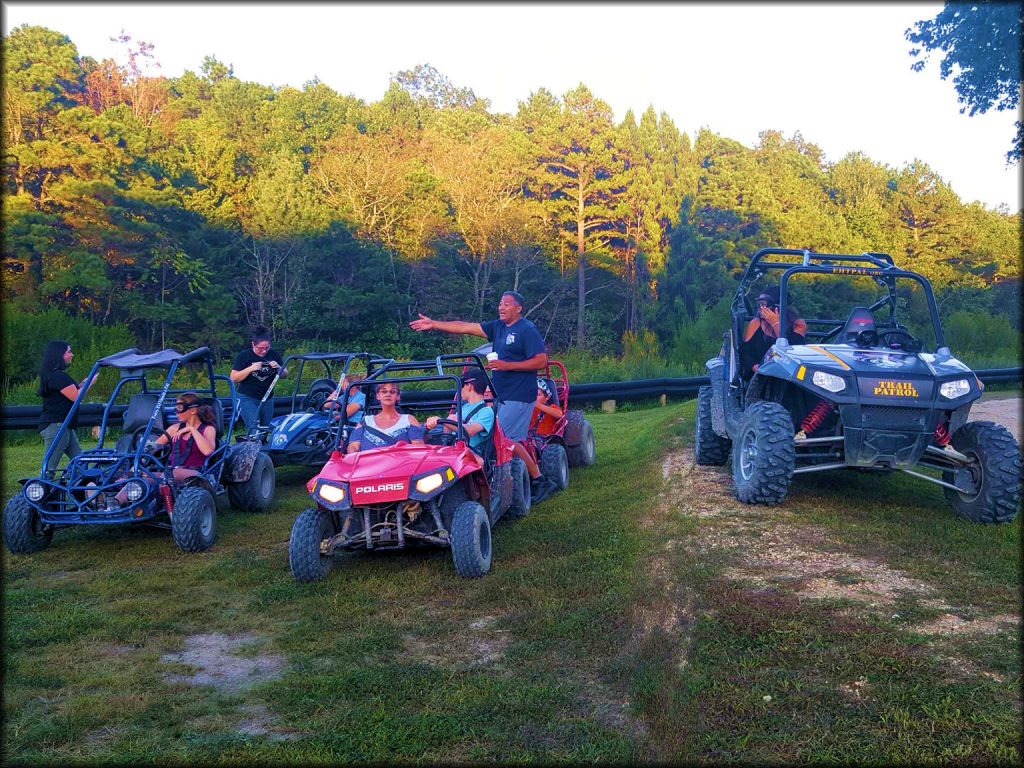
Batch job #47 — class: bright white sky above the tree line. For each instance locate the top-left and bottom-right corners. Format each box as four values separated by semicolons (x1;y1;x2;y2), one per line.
2;2;1021;211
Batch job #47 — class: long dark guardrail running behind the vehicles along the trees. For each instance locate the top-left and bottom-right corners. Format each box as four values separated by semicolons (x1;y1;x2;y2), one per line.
0;368;1024;430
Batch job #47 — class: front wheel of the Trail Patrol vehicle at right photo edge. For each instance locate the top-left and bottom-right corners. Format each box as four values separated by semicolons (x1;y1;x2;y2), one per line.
942;421;1021;523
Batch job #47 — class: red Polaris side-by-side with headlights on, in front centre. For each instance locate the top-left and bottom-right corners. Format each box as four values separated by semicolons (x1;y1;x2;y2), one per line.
288;354;530;582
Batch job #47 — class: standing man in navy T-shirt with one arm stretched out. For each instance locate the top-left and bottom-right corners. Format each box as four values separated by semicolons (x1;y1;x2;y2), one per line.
409;291;554;502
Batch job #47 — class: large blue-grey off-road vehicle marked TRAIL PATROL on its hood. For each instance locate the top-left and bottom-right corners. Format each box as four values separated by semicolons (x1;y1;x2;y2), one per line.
695;248;1021;523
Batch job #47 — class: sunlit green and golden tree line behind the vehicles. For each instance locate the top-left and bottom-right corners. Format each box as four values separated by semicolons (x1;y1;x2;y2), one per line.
0;26;1021;391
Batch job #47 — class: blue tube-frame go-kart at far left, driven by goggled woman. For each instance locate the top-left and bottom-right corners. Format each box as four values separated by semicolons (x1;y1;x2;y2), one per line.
2;347;274;554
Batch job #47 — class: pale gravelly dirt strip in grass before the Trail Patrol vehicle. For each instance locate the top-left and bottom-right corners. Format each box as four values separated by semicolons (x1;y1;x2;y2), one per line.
659;438;1021;679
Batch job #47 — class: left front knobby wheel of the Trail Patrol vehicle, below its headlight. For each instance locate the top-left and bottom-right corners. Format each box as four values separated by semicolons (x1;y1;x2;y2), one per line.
732;400;797;504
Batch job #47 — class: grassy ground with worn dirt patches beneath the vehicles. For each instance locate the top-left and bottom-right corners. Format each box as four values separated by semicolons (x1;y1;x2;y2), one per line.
2;401;1021;765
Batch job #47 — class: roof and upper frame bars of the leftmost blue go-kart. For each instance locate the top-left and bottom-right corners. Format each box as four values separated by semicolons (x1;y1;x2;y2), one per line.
39;346;234;476
